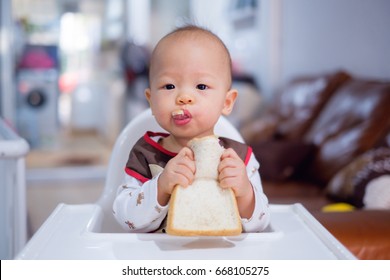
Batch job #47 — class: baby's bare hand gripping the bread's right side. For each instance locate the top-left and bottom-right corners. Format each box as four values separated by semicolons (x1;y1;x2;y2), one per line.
218;148;252;198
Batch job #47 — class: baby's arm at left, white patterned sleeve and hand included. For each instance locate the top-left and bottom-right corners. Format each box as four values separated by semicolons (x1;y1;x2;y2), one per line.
113;148;195;232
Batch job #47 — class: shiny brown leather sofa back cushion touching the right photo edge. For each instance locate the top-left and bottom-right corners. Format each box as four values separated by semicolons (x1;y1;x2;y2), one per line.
304;79;390;185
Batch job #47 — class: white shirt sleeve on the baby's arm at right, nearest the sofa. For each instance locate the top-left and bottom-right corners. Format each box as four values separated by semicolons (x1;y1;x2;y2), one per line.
241;154;270;232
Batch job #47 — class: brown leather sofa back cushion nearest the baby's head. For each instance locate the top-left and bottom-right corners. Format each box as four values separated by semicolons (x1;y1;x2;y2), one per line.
240;71;350;145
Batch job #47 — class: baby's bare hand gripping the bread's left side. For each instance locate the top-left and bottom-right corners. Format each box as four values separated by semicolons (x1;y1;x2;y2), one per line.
158;147;196;205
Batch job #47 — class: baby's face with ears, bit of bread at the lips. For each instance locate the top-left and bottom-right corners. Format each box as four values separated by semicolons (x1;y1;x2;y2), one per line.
145;35;237;139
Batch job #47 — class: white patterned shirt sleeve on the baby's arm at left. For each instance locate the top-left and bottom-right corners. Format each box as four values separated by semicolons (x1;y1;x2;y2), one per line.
113;172;168;233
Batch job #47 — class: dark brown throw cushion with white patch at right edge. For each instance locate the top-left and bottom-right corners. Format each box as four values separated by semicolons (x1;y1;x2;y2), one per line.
326;147;390;209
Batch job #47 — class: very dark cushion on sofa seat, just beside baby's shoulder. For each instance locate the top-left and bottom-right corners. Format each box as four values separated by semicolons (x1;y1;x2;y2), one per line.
252;140;314;181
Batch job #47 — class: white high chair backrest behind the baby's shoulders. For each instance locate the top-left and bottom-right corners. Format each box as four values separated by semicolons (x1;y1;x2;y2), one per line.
97;109;244;232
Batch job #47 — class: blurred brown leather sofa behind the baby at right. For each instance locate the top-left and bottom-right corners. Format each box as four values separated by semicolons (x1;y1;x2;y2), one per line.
241;71;390;259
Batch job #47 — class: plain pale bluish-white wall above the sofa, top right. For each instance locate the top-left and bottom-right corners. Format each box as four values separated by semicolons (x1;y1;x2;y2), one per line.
280;0;390;82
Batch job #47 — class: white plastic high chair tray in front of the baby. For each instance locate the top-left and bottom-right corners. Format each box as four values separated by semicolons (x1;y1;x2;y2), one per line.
17;204;355;260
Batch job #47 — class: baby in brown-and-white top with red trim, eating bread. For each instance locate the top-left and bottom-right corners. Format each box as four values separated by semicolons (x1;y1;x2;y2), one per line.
113;26;270;232
